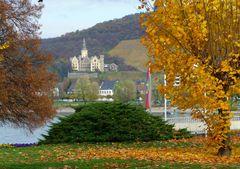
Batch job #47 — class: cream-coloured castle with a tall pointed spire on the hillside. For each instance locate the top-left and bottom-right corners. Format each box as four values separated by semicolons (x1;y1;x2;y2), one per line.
70;39;104;72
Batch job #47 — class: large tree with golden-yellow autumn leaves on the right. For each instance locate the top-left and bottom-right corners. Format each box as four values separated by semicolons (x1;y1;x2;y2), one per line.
139;0;240;156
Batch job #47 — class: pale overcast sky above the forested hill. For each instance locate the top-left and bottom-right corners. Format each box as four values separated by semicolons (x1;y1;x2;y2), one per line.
40;0;139;38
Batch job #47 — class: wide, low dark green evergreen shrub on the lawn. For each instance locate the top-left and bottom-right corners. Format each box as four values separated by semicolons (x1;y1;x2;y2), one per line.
39;103;192;144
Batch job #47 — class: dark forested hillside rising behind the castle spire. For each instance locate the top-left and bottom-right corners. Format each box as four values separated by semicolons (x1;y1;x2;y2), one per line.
42;14;143;59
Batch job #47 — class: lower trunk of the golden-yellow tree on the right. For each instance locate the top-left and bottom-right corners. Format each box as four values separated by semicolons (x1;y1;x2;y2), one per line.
217;109;232;156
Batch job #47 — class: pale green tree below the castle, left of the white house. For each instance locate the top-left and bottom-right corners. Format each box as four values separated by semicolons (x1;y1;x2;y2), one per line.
73;76;99;103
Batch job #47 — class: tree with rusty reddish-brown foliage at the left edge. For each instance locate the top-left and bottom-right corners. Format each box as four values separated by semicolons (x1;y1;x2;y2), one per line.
0;0;55;129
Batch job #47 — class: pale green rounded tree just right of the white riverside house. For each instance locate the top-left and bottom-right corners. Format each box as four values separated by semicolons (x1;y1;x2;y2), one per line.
113;80;137;102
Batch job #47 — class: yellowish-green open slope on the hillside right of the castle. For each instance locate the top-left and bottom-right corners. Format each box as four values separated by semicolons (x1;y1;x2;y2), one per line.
109;39;148;70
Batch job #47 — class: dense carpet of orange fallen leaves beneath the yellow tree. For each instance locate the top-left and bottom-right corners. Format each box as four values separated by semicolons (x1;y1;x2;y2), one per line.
38;143;240;165
